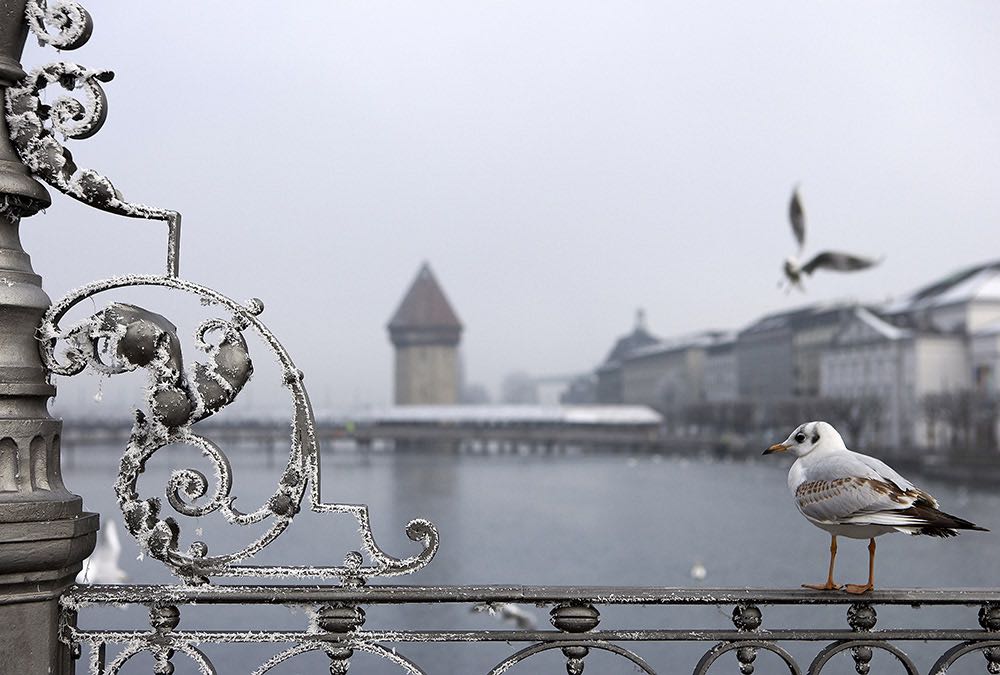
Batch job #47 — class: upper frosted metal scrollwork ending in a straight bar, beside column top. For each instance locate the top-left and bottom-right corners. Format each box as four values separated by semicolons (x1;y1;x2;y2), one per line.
5;0;181;277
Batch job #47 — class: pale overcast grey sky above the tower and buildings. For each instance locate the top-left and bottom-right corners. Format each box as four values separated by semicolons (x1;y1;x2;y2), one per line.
22;0;1000;418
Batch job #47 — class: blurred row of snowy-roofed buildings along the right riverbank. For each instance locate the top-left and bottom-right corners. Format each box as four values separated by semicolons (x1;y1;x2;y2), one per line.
584;261;1000;448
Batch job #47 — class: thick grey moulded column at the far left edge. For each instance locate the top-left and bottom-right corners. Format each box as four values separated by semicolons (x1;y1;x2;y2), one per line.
0;0;98;675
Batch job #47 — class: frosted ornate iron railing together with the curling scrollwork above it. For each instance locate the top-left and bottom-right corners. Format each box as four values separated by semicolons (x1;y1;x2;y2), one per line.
0;0;1000;675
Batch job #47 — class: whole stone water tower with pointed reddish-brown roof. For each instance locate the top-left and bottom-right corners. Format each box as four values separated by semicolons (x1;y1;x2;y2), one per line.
388;262;462;405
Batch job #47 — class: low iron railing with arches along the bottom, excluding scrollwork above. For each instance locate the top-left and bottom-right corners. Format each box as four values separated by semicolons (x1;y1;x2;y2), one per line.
63;585;1000;675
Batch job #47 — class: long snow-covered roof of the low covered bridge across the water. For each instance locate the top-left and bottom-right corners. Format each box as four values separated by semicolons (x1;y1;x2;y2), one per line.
336;405;663;426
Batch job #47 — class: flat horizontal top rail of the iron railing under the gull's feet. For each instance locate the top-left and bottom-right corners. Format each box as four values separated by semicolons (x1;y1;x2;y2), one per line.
64;584;1000;606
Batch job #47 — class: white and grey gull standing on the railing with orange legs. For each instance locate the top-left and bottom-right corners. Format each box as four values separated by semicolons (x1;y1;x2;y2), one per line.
764;422;988;593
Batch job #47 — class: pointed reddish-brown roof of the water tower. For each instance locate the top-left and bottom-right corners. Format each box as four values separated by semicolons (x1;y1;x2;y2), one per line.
388;262;462;346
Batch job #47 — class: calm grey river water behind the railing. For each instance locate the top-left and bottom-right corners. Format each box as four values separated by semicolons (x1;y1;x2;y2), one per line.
64;446;1000;674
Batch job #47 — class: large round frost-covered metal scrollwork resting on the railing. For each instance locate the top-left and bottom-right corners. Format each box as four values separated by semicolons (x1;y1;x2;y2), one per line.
40;276;438;583
